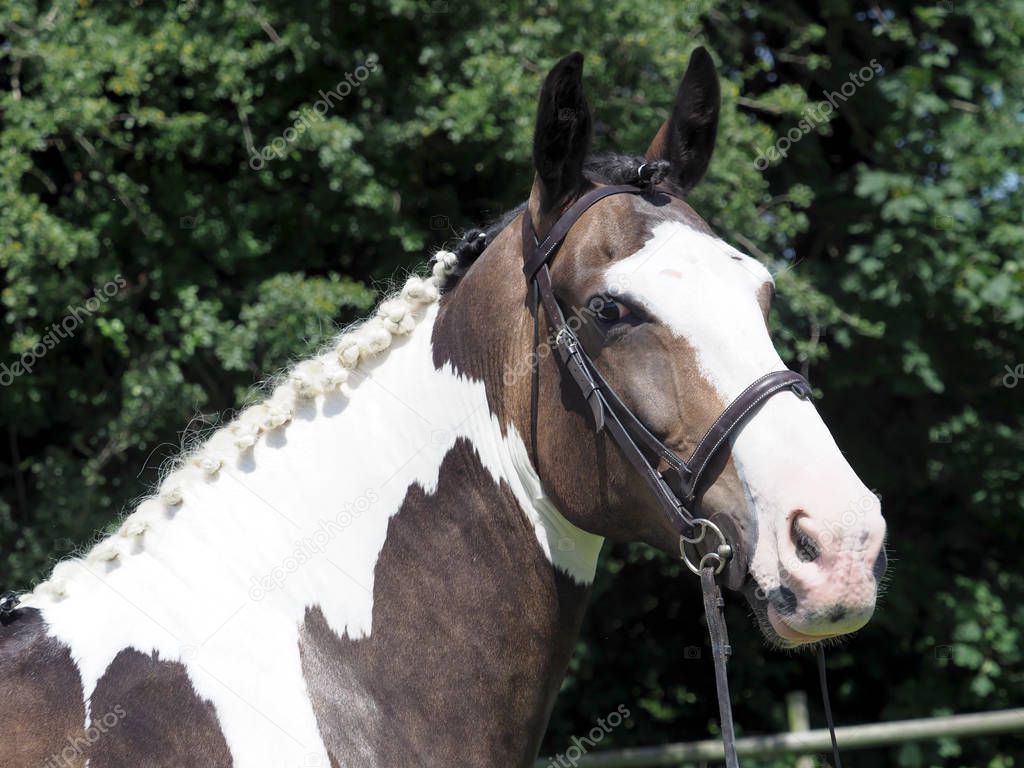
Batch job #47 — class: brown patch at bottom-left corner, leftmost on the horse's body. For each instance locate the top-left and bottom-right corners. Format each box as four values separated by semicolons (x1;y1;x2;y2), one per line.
0;608;88;768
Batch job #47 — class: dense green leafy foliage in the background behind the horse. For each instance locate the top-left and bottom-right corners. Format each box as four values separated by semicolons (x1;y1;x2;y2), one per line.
0;0;1024;768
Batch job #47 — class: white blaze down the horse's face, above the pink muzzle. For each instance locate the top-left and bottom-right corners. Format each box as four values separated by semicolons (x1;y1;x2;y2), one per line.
606;221;880;588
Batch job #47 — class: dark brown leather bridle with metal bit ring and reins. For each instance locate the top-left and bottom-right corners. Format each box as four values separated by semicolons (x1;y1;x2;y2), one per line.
522;179;841;768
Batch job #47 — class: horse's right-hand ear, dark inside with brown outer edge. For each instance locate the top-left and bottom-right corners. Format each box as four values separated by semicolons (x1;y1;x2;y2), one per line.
646;47;722;194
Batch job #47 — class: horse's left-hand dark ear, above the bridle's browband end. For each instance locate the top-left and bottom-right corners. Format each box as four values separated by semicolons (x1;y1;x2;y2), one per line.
534;52;591;212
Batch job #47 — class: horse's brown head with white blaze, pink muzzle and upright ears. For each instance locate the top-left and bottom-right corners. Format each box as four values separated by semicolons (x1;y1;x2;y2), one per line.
435;49;886;646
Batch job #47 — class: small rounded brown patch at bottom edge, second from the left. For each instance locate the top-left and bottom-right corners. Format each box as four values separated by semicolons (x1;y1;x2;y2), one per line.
88;648;231;768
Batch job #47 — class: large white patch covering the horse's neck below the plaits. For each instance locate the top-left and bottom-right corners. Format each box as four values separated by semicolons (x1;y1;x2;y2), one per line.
25;303;602;768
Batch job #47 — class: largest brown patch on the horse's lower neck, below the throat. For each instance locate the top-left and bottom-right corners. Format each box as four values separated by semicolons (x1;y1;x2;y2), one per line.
299;440;588;768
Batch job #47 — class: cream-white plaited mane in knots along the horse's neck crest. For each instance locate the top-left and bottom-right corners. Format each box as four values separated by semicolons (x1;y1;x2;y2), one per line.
20;251;460;606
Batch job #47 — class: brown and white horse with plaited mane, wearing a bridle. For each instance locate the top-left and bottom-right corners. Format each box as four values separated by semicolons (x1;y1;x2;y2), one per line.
0;48;886;768
